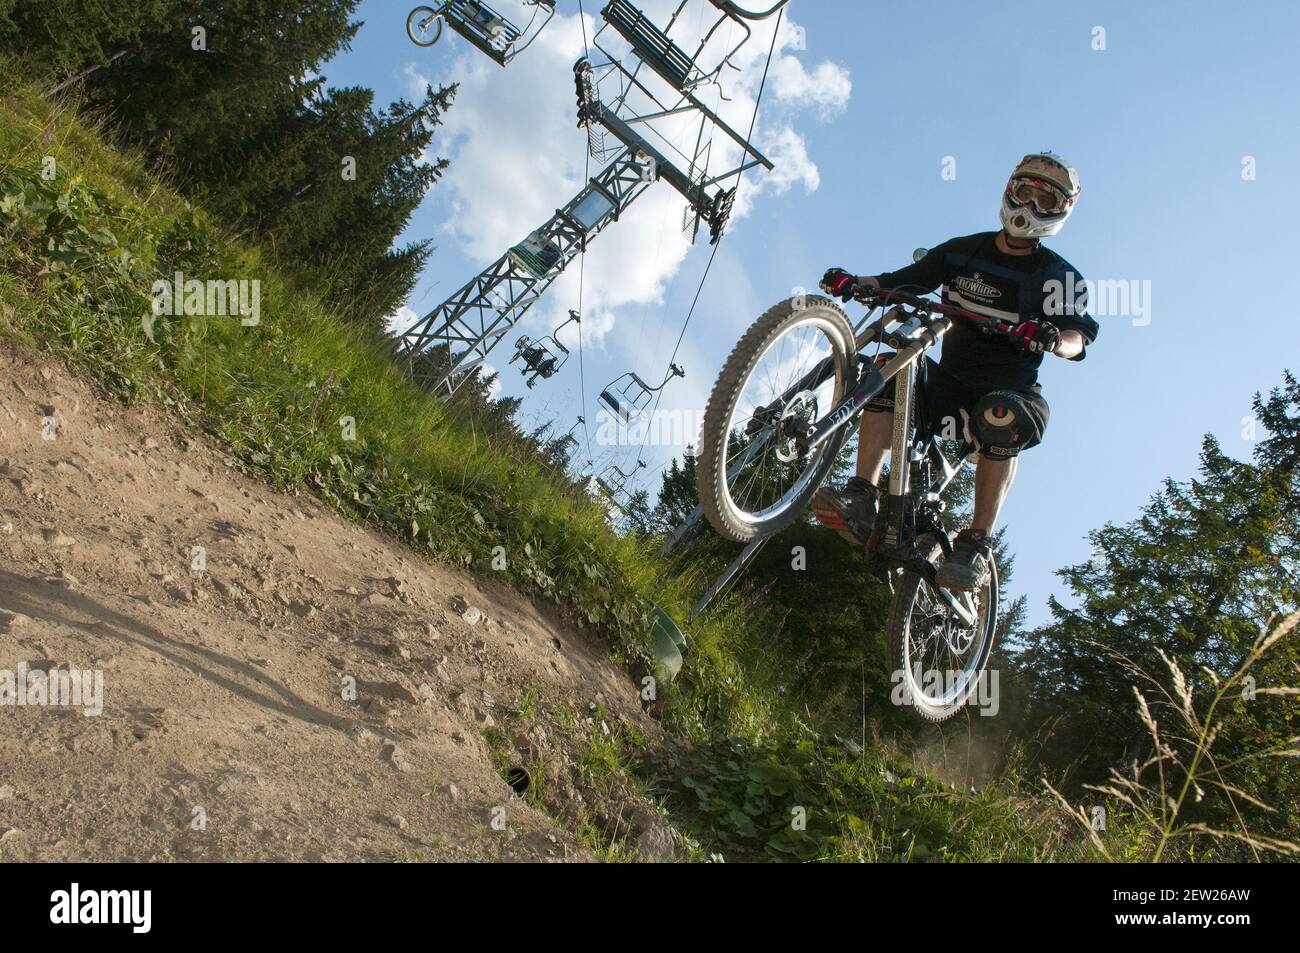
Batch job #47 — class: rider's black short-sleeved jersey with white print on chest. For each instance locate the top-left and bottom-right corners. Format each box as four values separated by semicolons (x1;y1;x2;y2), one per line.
880;231;1097;390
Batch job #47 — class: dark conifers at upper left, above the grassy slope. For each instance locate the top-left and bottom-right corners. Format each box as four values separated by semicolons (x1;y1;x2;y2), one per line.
0;0;455;330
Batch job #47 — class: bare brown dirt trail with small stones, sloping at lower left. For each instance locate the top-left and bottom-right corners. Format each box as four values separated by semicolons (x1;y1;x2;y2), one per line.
0;342;672;861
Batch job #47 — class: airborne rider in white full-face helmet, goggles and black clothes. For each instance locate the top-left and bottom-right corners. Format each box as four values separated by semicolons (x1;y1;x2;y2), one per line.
813;152;1097;590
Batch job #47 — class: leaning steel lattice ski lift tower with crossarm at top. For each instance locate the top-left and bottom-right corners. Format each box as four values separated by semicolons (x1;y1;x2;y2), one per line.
394;0;789;397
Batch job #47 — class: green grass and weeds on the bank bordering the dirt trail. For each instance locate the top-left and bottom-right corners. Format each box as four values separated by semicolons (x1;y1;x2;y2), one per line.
0;62;1118;859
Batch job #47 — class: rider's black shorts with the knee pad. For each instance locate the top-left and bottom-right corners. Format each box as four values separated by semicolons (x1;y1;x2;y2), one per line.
867;355;1050;460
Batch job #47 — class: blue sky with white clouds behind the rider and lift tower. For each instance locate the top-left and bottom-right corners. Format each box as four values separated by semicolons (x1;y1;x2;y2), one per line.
324;0;1300;621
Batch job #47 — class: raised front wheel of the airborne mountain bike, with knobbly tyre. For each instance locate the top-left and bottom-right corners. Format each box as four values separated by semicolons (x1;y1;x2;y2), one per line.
696;295;857;542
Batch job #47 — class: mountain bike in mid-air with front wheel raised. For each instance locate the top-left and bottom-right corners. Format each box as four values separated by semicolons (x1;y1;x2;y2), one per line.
696;287;1011;722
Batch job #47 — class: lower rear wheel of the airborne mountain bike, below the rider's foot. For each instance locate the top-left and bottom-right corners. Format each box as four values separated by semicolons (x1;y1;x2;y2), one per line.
888;536;998;724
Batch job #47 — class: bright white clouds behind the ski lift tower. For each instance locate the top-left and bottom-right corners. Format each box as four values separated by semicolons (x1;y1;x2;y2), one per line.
390;0;852;361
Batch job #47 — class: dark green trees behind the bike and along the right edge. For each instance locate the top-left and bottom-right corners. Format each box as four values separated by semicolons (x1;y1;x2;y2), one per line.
639;372;1300;859
